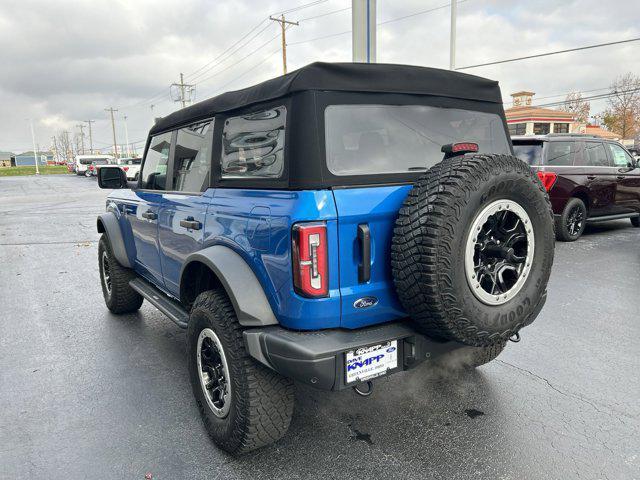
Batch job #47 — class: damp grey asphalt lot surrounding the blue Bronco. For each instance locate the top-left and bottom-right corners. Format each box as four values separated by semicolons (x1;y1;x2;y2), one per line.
0;176;640;479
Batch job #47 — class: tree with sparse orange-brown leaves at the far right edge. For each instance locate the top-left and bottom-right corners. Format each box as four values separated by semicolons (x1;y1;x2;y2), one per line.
603;72;640;138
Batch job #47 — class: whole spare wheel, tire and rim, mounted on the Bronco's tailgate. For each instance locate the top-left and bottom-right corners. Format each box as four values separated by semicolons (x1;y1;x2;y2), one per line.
391;154;555;346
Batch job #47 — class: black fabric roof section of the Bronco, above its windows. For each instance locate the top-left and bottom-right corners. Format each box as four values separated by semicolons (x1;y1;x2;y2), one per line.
150;62;502;135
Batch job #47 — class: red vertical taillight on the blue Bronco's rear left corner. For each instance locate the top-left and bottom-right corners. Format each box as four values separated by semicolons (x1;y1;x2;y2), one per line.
292;222;329;297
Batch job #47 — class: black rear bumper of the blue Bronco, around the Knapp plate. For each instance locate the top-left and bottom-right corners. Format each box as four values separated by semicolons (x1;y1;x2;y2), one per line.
244;322;465;390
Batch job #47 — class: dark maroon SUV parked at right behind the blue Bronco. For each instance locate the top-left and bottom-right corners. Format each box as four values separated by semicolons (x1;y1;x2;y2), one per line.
511;134;640;242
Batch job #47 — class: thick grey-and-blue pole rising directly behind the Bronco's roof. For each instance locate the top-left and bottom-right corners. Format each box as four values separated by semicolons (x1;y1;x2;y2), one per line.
351;0;377;63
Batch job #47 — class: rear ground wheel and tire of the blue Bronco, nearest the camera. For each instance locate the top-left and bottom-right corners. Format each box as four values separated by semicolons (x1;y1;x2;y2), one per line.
187;290;294;454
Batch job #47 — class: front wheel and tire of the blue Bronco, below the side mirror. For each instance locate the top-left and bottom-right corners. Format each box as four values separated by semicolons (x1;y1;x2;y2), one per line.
98;233;144;314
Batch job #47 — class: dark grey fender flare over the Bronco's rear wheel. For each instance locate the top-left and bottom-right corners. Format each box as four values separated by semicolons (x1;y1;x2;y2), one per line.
180;245;278;327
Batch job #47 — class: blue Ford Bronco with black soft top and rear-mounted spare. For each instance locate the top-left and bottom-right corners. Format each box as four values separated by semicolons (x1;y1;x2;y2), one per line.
97;63;554;453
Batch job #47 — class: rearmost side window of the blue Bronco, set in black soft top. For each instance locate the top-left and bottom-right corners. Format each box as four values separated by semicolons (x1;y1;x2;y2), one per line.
221;107;287;178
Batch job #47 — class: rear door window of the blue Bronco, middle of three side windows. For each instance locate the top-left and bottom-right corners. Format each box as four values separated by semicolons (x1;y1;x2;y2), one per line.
172;120;213;193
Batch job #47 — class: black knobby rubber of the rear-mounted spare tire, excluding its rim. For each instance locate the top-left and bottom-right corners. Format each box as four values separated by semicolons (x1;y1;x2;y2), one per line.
391;154;554;346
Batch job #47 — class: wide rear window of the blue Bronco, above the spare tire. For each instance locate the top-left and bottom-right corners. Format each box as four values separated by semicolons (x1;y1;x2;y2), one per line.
325;105;510;175
